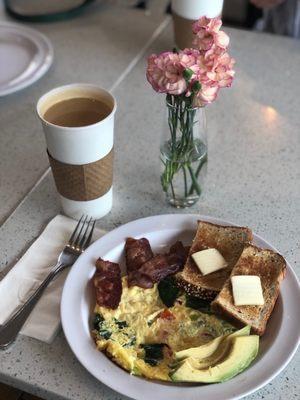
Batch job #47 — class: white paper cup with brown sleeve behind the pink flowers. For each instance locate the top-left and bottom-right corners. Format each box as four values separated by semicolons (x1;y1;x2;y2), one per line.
172;0;223;49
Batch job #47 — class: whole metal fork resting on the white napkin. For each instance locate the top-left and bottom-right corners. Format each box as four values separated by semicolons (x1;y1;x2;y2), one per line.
0;216;95;349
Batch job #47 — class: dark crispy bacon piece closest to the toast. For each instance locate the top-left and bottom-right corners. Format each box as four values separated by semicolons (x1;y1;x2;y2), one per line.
130;242;188;289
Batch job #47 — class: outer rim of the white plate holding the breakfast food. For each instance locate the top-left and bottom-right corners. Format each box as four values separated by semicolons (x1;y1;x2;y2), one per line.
61;214;300;400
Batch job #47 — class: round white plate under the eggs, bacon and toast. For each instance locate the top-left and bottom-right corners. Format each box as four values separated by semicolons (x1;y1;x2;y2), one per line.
61;214;300;400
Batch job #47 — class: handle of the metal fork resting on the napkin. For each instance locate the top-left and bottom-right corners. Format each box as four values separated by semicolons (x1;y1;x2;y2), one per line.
0;263;62;349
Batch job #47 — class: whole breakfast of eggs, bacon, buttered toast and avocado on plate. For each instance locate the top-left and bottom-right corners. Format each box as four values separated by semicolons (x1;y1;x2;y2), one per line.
92;221;285;383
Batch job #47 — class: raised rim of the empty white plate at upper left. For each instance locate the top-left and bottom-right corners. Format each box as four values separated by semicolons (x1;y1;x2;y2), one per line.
0;21;54;97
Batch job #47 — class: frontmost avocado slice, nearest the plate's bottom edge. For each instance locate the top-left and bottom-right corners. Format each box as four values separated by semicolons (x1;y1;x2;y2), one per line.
171;335;259;383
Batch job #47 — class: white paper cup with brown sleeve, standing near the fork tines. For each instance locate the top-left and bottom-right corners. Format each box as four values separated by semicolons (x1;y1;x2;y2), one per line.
37;83;117;219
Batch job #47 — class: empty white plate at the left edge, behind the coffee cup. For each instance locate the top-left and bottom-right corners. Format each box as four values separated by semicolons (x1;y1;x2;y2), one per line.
0;21;53;96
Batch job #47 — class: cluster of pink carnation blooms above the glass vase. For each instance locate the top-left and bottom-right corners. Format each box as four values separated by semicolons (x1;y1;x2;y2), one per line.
147;17;235;106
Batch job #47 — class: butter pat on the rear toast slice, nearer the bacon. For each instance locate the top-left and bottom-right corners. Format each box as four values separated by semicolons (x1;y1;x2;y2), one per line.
192;249;227;275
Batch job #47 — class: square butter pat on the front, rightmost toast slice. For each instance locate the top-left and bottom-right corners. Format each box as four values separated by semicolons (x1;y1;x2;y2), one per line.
231;275;264;306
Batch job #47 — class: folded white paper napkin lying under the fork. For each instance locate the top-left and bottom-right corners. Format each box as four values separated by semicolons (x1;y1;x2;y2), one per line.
0;215;105;343
